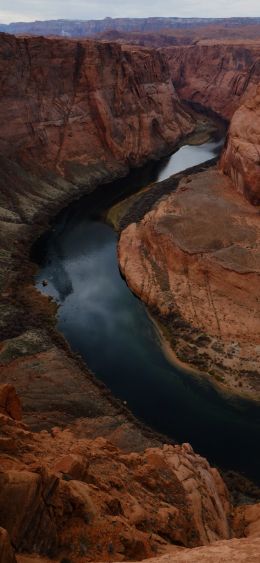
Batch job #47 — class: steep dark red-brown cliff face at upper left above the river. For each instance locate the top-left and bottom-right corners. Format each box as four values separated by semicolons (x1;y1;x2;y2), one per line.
0;35;193;183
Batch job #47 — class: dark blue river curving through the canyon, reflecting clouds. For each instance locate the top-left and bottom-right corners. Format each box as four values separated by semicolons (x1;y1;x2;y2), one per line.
33;142;260;482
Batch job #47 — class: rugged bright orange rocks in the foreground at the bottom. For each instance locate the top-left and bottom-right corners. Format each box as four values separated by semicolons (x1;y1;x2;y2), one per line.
0;386;232;561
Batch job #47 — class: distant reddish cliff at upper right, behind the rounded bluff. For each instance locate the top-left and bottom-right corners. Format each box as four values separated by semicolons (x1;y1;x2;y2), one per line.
164;41;260;120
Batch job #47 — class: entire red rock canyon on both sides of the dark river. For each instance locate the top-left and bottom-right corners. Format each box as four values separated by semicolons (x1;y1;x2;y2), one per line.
0;28;260;563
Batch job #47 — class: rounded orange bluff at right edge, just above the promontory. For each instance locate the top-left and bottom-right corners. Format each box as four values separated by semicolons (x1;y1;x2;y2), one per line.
221;86;260;204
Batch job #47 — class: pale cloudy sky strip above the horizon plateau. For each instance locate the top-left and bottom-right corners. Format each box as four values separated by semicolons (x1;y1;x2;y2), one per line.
0;0;260;23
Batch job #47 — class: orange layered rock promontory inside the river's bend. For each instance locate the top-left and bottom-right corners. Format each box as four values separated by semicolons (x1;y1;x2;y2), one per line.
118;165;260;400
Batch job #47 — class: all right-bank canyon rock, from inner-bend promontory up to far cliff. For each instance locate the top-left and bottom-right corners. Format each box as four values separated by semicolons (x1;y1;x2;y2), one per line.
119;44;260;400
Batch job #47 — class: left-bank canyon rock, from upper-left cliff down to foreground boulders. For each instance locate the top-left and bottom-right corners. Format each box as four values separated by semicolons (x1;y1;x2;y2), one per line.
0;30;236;561
